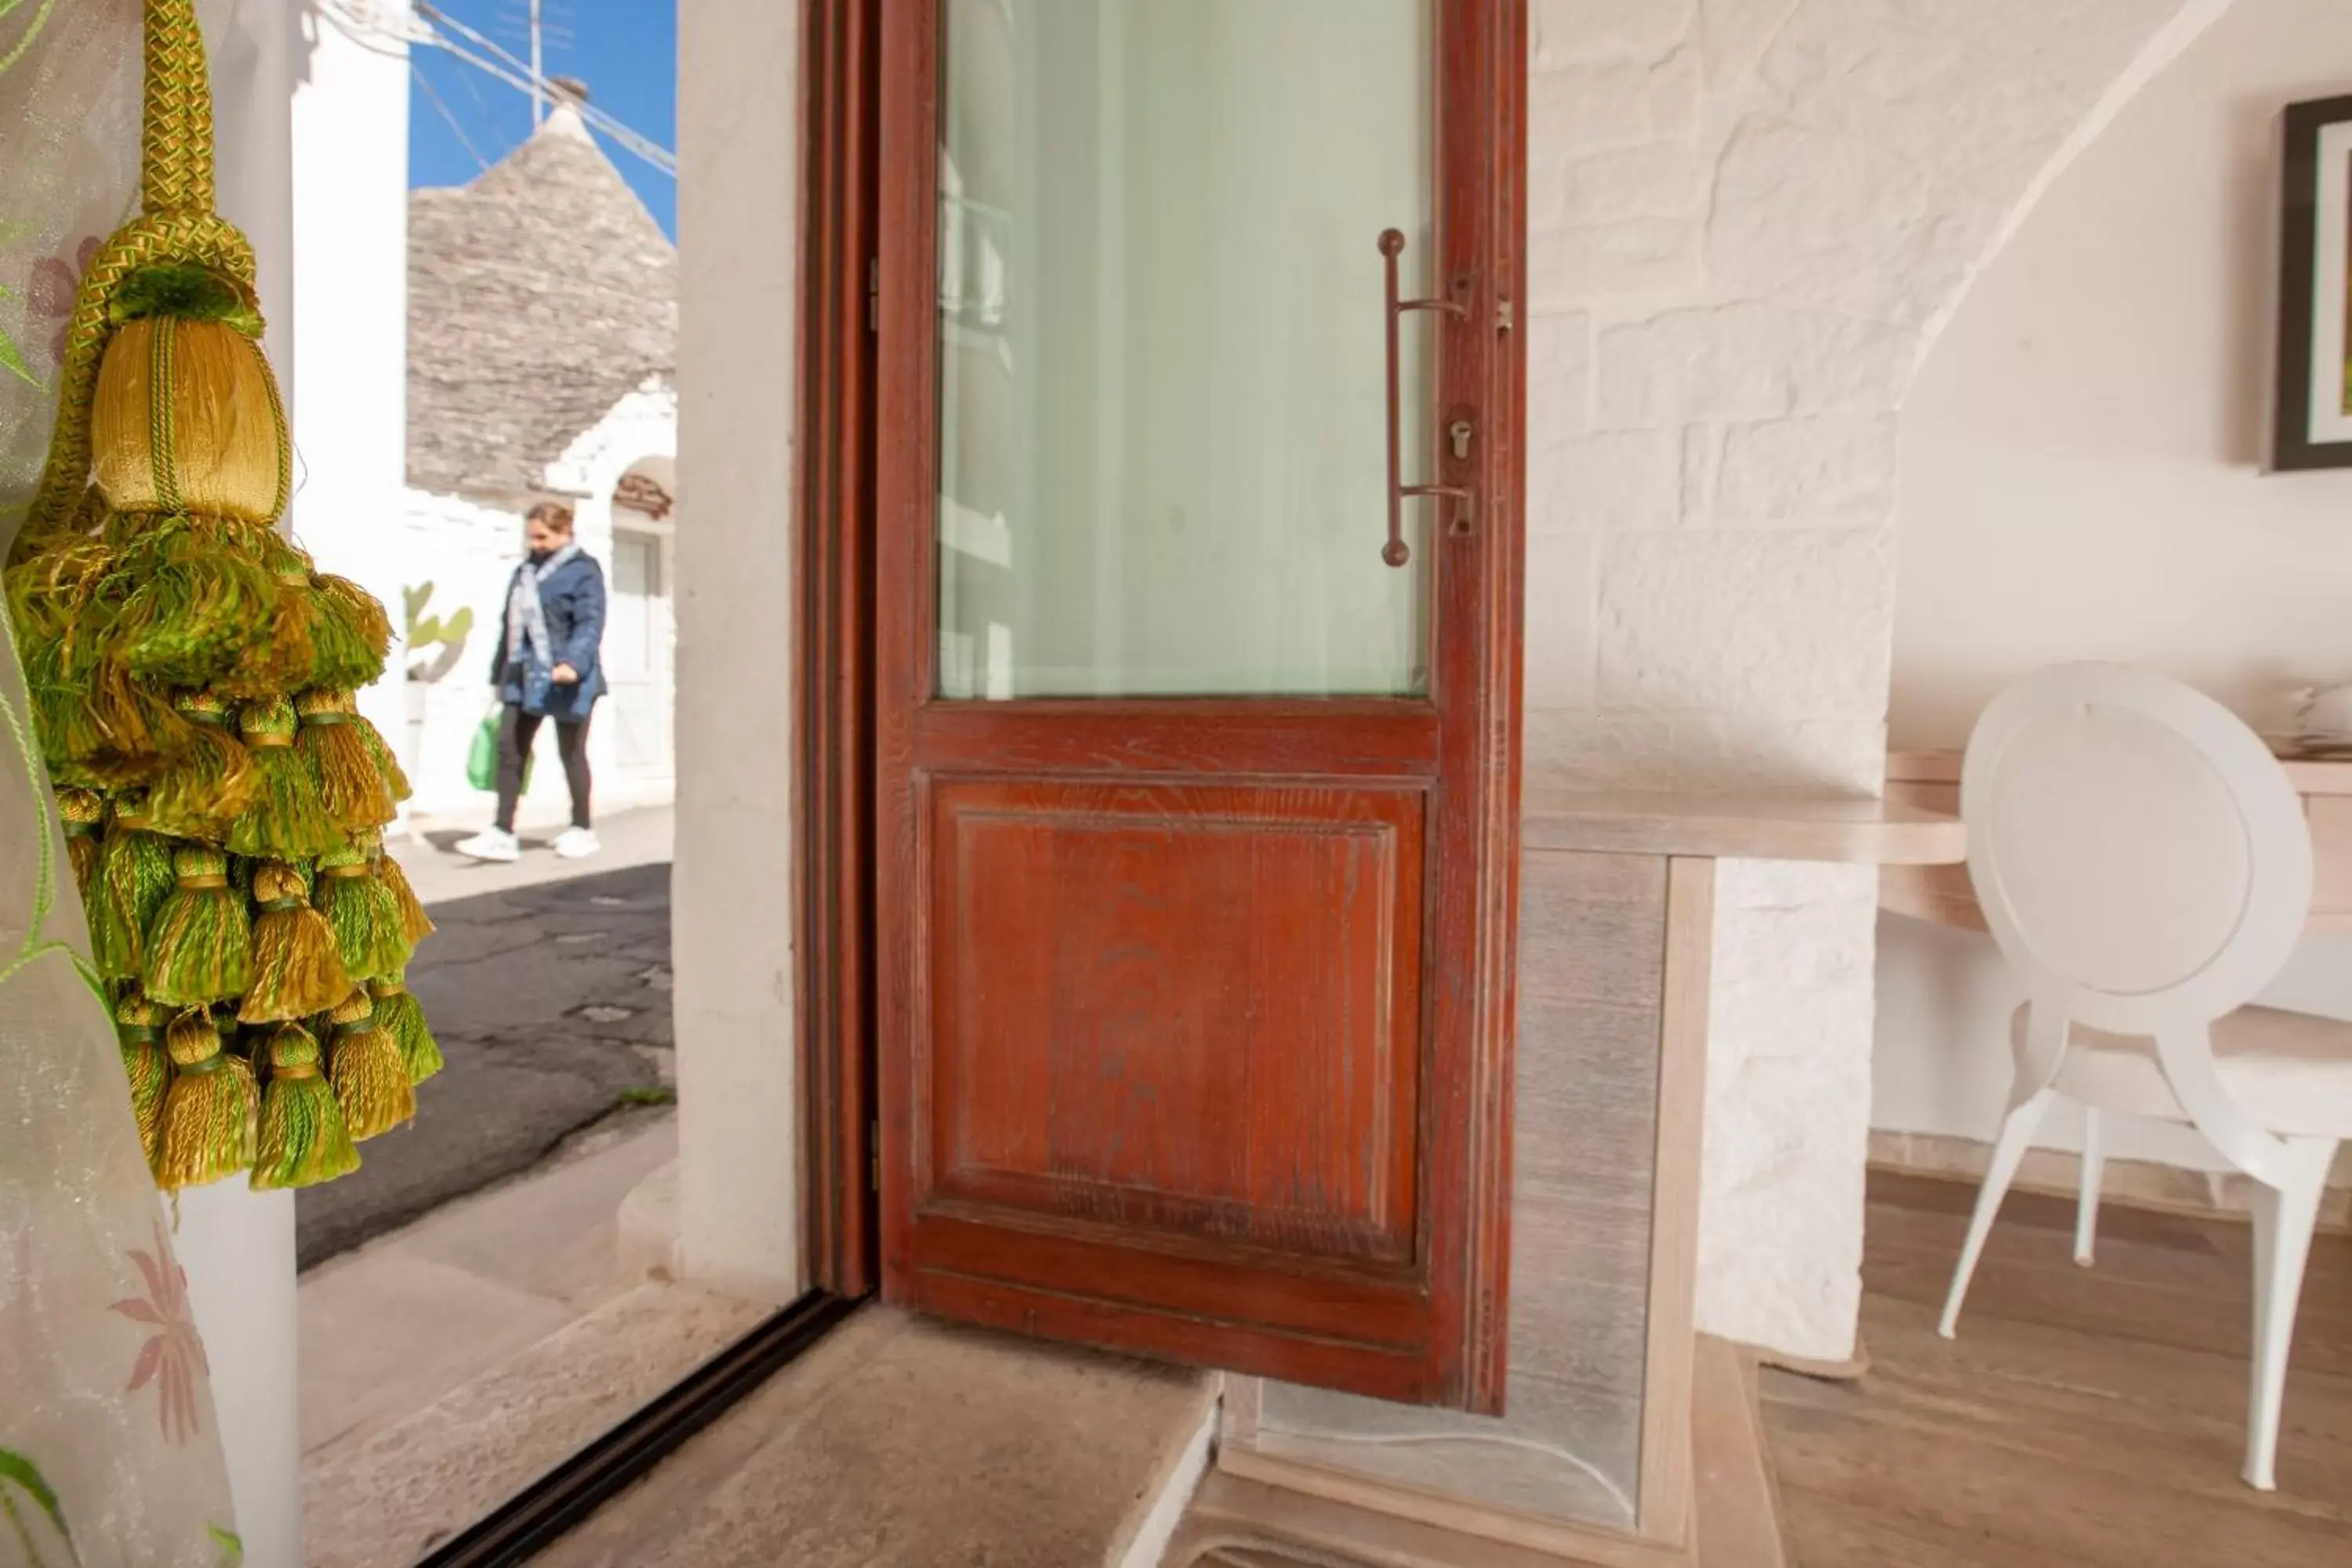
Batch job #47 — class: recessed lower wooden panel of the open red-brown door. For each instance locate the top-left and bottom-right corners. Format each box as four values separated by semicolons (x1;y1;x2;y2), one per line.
915;779;1423;1267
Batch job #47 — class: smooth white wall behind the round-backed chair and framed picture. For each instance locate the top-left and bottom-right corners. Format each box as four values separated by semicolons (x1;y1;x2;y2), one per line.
1872;0;2352;1189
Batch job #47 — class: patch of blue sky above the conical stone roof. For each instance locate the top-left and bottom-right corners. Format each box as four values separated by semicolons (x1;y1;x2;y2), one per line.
409;0;677;240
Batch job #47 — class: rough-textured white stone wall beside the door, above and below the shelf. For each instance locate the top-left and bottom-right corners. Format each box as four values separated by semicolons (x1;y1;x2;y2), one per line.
1526;0;2227;1359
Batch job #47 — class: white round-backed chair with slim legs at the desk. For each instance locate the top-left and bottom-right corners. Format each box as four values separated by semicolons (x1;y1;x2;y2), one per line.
1940;666;2352;1490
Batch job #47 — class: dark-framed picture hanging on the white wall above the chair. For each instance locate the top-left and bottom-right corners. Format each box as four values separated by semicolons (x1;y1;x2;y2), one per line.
2270;96;2352;468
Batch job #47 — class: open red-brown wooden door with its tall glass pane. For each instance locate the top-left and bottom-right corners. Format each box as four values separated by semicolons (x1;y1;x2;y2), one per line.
875;0;1524;1410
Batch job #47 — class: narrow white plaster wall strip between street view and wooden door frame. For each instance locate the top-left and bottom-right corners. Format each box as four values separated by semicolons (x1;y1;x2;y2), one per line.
670;0;802;1298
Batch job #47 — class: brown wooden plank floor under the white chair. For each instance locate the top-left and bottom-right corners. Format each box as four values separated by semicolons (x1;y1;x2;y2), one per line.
1764;1175;2352;1568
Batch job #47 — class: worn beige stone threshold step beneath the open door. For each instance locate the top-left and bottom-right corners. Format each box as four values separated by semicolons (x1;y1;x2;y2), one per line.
539;1307;1218;1568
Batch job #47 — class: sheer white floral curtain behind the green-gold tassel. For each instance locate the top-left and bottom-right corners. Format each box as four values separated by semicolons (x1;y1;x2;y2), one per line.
0;0;238;1568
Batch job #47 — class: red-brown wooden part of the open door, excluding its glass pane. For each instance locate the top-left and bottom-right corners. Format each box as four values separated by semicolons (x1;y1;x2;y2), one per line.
870;0;1526;1410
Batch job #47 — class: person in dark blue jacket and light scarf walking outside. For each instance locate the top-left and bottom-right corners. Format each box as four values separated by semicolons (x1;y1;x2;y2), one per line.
456;501;604;860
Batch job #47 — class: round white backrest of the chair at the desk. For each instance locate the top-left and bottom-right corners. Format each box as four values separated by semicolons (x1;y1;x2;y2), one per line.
1959;663;2312;1034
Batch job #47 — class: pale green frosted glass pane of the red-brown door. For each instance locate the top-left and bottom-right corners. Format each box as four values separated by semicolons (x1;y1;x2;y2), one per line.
936;0;1437;699
